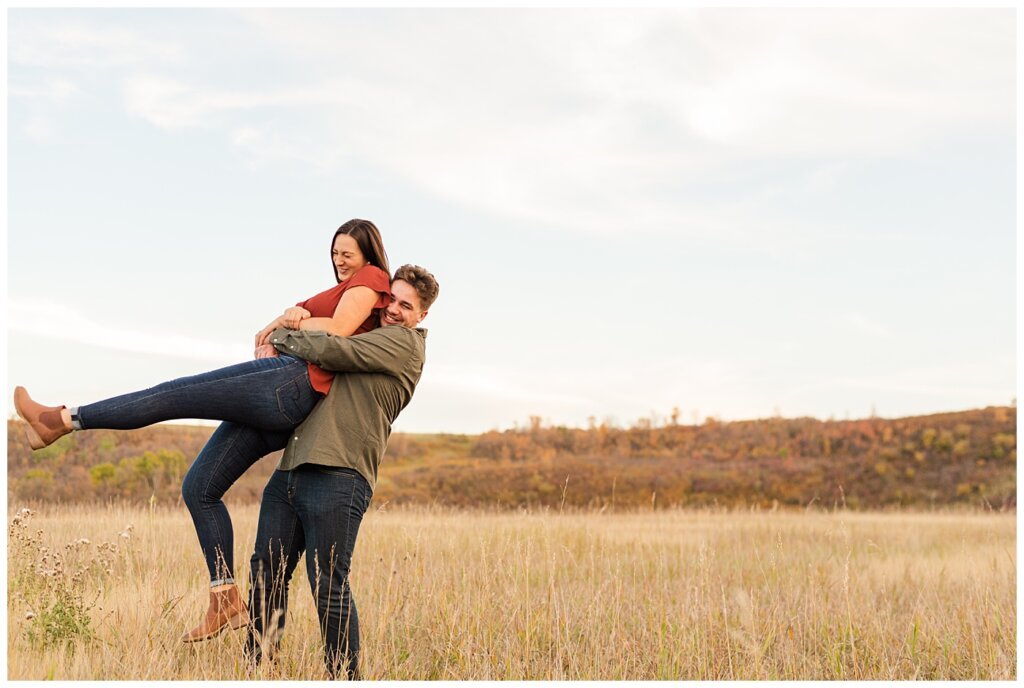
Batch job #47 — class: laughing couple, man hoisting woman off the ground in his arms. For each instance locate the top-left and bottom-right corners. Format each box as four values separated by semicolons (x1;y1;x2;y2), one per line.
14;219;438;679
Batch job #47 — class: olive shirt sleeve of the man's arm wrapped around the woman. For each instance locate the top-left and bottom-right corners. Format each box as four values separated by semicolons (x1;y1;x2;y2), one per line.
270;326;414;377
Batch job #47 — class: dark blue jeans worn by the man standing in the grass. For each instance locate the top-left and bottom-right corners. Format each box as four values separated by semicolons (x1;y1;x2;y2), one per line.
246;464;372;679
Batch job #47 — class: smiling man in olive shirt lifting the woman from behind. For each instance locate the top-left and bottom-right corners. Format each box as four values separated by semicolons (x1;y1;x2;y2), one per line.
246;265;438;679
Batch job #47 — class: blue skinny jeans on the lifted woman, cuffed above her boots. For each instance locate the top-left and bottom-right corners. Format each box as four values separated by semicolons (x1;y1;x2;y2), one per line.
78;355;321;586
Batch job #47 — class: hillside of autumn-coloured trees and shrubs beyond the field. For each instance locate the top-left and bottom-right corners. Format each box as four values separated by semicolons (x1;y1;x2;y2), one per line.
7;406;1017;509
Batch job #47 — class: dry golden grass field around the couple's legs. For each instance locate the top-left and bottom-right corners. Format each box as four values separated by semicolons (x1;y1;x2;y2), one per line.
7;506;1017;680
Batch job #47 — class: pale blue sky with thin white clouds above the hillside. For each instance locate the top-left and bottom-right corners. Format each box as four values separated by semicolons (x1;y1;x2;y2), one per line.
4;8;1017;433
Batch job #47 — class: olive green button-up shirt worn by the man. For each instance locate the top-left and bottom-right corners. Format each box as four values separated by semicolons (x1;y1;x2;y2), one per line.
270;325;427;489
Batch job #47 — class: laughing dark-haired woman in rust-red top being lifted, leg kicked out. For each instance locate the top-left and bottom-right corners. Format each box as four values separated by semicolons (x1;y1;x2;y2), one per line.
14;219;390;642
